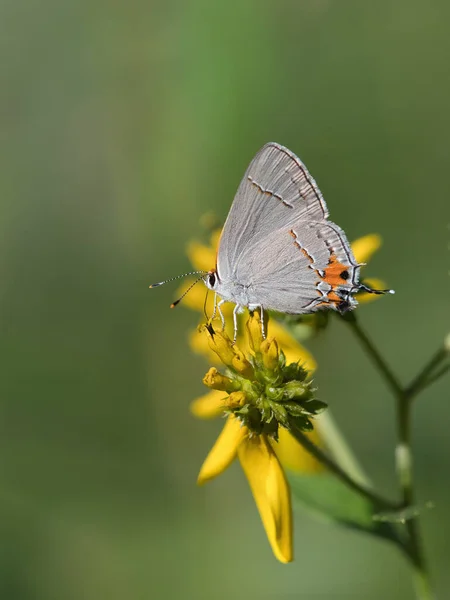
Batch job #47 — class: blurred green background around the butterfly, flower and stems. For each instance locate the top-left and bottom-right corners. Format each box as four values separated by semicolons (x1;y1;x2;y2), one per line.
0;0;450;600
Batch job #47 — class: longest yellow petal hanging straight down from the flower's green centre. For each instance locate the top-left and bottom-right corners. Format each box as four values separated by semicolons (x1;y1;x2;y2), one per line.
238;435;293;563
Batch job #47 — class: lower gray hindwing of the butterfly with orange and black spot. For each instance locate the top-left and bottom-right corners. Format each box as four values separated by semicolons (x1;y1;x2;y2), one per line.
236;221;359;314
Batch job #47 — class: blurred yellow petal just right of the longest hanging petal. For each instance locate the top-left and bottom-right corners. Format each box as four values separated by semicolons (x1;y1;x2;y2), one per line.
272;427;325;475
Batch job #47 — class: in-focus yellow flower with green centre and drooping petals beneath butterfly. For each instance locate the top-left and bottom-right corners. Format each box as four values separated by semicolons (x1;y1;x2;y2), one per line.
191;312;325;563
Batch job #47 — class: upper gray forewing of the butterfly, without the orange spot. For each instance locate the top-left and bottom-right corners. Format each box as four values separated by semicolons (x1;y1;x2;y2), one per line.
217;142;328;280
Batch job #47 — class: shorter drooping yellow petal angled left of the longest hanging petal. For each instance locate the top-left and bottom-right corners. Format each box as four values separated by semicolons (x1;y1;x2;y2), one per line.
197;415;248;485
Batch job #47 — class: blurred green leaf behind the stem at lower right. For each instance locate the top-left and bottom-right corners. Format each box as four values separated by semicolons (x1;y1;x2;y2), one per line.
288;472;401;543
